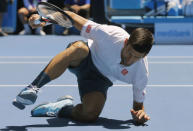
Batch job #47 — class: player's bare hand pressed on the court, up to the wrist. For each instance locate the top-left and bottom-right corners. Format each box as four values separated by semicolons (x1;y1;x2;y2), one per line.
131;109;150;124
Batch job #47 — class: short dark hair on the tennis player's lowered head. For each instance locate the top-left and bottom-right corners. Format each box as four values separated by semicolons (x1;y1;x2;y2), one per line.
128;28;154;54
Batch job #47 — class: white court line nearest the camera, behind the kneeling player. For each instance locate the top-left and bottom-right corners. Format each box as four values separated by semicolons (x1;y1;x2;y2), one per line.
0;84;193;87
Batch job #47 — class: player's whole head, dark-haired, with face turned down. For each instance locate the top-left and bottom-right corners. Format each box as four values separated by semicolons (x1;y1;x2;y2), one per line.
121;28;154;66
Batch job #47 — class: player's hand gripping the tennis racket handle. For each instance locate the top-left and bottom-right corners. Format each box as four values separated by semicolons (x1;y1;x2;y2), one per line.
29;14;46;29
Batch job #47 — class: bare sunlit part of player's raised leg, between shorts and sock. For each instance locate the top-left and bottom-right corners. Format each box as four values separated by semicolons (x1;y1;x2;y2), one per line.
44;41;89;80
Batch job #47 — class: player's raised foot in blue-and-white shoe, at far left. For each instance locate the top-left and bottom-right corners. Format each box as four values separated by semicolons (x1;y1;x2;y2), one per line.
13;85;39;109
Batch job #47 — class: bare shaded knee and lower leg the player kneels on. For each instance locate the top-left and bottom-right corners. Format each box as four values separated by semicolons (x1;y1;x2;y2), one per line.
58;92;106;123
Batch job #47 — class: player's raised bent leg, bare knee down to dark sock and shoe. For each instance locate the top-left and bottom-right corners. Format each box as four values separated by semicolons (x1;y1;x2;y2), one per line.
13;41;89;109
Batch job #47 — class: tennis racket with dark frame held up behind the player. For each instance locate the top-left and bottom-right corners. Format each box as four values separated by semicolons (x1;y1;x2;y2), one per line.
34;2;73;28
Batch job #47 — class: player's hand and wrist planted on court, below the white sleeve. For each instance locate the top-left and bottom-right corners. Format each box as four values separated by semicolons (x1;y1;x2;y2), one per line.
131;101;150;124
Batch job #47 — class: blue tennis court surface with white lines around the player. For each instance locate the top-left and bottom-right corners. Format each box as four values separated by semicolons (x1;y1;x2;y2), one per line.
0;36;193;131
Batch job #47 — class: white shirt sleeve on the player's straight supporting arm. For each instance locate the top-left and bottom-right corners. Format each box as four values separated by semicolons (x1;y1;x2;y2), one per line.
132;59;148;103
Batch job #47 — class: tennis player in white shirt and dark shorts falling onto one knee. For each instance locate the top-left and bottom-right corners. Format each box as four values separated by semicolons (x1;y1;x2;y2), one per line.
13;11;153;123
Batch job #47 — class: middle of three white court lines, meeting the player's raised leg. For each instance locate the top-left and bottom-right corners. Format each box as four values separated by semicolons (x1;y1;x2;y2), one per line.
0;61;193;64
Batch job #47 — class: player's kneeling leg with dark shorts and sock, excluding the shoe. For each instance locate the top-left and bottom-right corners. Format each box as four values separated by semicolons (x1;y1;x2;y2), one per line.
58;40;112;122
